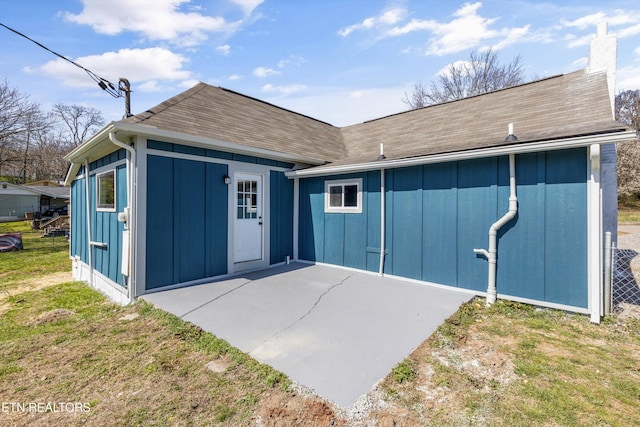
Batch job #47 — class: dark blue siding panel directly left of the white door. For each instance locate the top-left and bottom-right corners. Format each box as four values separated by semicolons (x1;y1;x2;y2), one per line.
145;155;228;289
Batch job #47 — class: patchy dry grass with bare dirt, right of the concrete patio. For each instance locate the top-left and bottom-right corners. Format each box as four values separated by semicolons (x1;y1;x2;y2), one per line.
370;300;640;426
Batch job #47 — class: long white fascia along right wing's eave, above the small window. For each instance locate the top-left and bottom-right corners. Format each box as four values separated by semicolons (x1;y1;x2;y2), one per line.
285;131;636;178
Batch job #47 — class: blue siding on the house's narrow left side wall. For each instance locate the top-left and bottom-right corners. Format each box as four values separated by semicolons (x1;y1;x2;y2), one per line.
70;150;127;286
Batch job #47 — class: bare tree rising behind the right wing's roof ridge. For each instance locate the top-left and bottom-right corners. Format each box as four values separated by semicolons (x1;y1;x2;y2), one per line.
402;49;524;109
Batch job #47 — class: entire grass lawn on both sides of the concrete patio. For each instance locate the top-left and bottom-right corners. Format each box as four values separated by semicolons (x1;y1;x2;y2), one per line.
0;224;640;426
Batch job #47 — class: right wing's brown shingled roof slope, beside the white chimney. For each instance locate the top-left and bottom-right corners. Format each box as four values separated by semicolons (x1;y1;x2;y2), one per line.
341;71;624;163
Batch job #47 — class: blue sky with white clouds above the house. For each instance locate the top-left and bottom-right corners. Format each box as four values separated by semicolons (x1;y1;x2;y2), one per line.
0;0;640;126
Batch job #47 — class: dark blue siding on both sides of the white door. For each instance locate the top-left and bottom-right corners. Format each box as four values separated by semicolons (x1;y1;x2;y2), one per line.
145;148;293;290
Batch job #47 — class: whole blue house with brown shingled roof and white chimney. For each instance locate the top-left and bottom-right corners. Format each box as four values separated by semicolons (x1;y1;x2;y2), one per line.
67;28;635;321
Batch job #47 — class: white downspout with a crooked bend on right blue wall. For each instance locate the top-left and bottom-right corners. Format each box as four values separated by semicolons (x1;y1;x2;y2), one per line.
473;124;518;305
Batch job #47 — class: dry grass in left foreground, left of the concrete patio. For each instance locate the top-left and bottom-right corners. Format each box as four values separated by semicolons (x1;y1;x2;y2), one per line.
0;283;350;426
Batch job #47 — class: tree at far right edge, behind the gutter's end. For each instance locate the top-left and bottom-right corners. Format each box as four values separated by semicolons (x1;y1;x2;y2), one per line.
616;89;640;203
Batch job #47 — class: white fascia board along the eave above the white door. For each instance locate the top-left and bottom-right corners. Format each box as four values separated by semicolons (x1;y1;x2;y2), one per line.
114;122;326;165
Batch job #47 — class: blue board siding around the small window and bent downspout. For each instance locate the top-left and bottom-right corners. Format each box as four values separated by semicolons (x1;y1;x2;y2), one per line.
299;148;588;308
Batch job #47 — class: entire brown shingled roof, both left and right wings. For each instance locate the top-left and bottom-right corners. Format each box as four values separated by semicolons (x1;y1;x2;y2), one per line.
124;70;624;164
